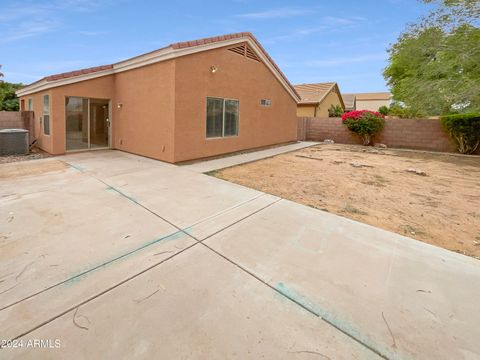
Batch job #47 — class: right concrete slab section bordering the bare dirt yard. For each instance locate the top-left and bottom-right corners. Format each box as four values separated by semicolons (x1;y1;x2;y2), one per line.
205;200;480;359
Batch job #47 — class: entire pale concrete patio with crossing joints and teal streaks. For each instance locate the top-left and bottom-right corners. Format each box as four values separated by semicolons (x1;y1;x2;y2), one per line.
0;151;480;359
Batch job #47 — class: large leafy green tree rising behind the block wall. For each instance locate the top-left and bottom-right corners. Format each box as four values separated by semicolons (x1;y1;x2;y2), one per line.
384;0;480;115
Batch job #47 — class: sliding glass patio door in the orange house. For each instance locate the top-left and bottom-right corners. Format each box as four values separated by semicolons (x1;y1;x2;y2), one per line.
65;96;110;151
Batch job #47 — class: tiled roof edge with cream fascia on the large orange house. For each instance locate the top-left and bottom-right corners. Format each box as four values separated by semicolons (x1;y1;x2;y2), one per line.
17;32;300;101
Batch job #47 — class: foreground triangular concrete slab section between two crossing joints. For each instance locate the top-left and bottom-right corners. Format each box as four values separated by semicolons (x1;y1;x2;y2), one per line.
2;244;376;359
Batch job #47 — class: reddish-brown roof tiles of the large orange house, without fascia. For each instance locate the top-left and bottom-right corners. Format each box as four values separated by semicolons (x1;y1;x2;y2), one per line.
28;32;300;97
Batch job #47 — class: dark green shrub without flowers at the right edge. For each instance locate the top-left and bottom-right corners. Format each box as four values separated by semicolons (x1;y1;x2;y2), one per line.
440;113;480;154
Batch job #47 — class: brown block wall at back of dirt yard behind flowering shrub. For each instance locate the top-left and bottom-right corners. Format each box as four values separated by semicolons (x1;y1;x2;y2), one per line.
298;118;480;154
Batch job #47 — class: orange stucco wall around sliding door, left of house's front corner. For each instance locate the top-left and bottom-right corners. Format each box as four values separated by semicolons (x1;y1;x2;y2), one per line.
21;60;174;162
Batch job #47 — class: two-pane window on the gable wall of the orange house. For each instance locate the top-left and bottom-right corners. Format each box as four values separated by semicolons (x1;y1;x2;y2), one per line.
207;97;240;138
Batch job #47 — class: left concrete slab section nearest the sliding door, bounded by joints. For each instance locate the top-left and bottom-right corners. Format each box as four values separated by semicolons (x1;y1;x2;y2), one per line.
0;162;187;308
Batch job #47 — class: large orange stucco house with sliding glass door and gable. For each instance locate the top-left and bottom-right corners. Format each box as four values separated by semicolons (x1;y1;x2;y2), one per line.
17;33;300;163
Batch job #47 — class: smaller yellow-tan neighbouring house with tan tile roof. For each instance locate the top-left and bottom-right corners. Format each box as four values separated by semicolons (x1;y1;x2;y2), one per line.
295;82;345;117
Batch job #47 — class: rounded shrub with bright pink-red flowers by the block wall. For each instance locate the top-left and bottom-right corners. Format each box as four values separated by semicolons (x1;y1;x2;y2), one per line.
342;110;385;145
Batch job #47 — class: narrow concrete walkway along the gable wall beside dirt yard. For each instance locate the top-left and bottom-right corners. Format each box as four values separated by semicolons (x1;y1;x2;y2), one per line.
182;141;319;173
